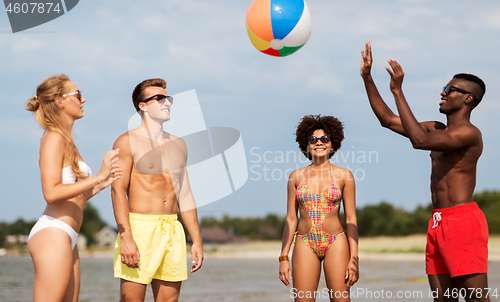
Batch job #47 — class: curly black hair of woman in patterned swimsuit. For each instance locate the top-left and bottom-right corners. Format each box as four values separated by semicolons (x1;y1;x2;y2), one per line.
295;114;344;160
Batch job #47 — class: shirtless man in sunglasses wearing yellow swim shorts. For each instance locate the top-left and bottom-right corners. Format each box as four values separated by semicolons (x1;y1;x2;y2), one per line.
111;79;203;302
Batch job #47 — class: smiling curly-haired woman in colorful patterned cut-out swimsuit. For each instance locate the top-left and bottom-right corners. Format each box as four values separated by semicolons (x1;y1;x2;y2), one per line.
279;115;359;301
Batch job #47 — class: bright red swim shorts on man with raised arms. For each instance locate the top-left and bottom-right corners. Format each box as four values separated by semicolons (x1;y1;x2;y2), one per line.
425;202;488;277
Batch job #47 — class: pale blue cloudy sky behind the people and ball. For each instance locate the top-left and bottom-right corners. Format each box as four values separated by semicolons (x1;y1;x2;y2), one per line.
0;0;500;224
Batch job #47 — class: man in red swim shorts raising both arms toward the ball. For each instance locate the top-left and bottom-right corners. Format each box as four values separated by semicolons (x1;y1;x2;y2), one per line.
360;42;490;301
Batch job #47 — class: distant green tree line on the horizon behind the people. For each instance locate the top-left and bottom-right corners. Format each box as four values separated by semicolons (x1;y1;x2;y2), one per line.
0;190;500;246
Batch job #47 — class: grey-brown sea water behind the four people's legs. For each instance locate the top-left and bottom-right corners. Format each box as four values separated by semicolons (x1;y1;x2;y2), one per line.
0;257;500;302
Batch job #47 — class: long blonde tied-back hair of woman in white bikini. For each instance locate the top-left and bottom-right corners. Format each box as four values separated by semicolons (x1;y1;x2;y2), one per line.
26;74;86;178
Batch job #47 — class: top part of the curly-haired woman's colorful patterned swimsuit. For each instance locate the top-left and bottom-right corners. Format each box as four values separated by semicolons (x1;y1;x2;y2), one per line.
295;166;342;212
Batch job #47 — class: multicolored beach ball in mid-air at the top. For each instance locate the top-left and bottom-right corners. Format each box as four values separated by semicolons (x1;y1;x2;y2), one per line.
246;0;311;57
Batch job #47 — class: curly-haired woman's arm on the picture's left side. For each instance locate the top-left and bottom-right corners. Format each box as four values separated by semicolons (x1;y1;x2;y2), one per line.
279;170;299;286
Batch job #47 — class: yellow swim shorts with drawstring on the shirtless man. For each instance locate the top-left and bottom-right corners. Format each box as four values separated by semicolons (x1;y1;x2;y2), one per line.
114;213;187;284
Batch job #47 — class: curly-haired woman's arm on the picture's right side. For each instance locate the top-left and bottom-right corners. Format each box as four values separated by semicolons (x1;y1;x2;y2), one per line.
342;169;359;286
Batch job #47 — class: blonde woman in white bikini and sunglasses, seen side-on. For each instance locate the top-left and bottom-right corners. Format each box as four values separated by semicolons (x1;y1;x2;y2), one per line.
26;75;122;302
